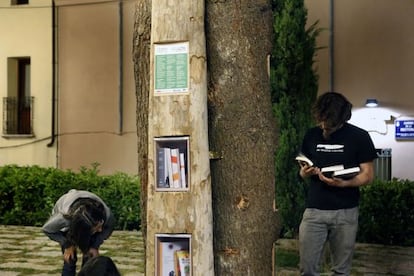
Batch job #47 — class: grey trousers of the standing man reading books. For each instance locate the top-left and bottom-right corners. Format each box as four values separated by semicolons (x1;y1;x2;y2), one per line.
299;207;359;276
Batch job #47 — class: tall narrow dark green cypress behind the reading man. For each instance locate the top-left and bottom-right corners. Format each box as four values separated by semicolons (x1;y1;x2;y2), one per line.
271;0;321;237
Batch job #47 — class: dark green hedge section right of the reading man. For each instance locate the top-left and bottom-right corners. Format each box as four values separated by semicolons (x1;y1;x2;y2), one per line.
358;179;414;246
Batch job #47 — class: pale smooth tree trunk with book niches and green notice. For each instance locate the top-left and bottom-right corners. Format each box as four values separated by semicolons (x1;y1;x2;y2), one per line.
134;0;214;275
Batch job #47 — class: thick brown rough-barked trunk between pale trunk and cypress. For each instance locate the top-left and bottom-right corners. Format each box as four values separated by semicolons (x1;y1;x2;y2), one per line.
206;0;279;275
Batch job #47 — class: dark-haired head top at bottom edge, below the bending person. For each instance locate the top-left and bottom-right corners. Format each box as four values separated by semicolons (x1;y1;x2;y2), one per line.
78;256;121;276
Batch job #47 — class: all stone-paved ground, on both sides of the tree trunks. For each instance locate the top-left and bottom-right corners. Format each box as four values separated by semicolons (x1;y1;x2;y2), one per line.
0;225;414;276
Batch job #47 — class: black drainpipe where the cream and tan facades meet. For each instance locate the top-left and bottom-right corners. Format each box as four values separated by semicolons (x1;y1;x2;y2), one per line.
47;0;56;147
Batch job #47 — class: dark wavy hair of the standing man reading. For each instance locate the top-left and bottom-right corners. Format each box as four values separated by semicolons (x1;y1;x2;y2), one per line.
312;92;352;127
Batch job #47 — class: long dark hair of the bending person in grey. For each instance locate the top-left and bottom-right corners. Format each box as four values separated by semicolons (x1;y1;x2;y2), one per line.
65;198;106;253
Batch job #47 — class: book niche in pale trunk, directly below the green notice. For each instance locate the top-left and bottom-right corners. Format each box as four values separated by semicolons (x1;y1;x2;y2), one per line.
154;136;189;192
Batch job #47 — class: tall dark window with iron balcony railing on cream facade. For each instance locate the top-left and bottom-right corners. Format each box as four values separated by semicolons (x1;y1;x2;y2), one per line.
3;57;33;135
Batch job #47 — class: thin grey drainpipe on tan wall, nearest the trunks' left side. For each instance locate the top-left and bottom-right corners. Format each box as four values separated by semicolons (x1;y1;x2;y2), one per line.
118;1;124;135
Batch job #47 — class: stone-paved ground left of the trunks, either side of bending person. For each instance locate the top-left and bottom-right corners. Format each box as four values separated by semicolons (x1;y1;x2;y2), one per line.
0;225;144;276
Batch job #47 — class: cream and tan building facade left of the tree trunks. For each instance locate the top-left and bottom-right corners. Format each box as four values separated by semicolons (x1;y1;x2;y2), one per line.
0;0;137;174
